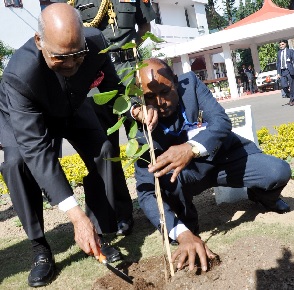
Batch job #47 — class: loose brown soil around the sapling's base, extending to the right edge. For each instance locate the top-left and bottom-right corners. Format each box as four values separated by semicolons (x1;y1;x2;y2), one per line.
92;237;294;290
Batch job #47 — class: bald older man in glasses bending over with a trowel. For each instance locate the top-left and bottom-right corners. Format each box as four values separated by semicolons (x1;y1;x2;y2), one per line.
0;3;124;287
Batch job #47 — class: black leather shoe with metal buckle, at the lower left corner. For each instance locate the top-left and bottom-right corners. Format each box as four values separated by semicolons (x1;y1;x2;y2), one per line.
28;253;55;287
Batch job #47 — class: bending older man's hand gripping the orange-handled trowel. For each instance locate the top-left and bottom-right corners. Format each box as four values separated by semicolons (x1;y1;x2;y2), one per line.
66;206;100;256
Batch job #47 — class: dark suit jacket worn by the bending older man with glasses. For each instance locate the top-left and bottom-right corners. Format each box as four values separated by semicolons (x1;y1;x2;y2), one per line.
0;28;119;204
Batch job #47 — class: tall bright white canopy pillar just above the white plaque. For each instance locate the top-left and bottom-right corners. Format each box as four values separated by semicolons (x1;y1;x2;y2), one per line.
222;44;239;98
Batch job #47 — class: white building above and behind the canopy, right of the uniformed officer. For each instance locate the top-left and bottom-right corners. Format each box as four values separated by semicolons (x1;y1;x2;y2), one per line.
151;0;226;79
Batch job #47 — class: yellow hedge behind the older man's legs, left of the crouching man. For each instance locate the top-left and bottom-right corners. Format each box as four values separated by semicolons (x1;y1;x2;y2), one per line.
0;145;135;194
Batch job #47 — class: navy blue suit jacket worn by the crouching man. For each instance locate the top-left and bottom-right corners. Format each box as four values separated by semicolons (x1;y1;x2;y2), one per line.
135;72;260;231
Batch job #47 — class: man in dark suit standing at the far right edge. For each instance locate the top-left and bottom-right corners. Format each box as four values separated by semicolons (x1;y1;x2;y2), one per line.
277;40;294;106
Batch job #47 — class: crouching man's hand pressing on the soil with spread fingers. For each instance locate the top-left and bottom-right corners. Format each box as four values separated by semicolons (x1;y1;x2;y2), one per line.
172;231;216;271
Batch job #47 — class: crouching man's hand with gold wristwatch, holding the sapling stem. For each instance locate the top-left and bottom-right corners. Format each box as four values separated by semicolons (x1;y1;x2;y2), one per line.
148;143;193;182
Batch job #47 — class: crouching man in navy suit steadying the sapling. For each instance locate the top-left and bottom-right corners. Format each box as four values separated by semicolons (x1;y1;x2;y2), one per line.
132;59;291;270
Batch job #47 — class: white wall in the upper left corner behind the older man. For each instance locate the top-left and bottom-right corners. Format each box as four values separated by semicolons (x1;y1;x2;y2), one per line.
0;0;41;49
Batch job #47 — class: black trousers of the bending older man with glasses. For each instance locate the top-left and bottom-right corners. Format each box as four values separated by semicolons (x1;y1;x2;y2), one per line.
1;115;117;240
